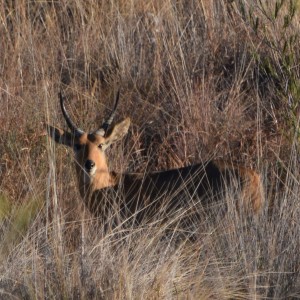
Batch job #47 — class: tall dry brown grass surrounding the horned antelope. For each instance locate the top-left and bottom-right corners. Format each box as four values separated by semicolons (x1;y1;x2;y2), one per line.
0;0;300;299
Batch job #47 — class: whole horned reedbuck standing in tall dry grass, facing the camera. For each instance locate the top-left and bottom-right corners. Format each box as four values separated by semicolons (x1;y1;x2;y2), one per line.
47;93;263;226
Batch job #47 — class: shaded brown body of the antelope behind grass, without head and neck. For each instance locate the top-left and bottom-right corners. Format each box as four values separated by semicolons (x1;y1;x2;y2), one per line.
88;161;264;223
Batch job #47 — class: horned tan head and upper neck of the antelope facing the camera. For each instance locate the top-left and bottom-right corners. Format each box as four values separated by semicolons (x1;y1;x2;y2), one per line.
47;92;130;197
